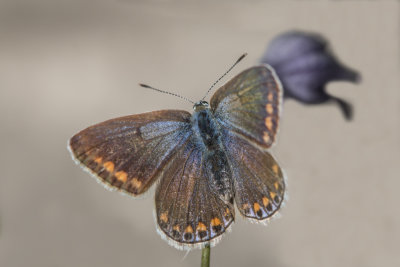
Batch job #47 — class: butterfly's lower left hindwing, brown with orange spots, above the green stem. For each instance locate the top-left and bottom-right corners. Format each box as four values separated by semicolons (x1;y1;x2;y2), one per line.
156;141;234;249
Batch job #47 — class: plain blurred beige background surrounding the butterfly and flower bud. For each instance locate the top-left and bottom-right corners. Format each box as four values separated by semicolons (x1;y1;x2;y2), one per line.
0;0;400;267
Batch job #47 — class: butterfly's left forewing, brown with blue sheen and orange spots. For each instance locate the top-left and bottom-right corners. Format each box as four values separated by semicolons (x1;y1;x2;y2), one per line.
69;110;191;196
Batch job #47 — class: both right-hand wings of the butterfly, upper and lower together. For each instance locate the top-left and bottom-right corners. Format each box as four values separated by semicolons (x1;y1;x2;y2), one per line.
210;65;285;221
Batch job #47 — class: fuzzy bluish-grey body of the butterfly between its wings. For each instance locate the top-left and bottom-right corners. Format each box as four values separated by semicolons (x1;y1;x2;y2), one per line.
192;101;234;203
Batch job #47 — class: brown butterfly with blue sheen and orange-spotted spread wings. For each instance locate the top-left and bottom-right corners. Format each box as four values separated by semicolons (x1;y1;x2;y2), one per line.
69;58;285;249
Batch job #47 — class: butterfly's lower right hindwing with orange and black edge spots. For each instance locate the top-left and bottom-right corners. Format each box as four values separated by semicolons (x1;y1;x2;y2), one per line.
223;131;285;221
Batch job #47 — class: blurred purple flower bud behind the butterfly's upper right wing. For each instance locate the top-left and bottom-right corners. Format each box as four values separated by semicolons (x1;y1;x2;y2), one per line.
261;31;360;119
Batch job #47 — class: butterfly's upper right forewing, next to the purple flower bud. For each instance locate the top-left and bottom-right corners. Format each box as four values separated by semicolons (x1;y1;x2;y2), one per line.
210;65;282;148
